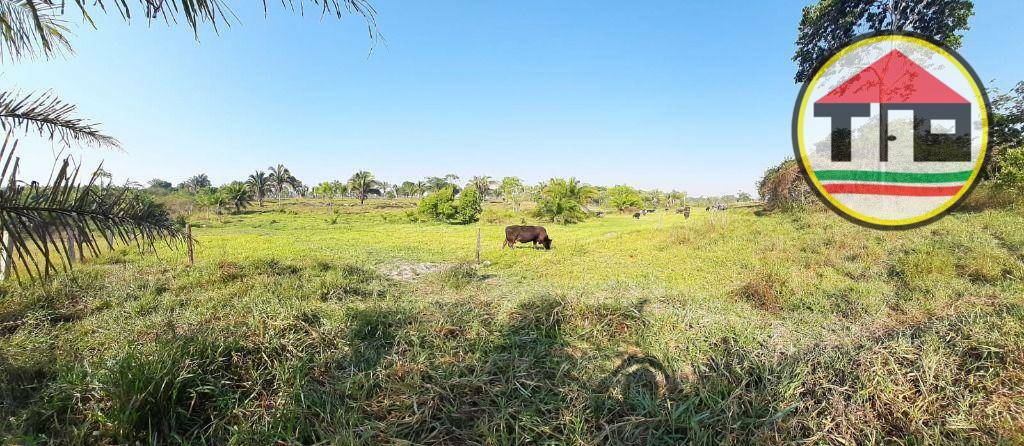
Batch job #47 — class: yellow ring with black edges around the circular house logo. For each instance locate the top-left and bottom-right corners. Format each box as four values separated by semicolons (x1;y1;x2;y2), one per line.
795;34;988;228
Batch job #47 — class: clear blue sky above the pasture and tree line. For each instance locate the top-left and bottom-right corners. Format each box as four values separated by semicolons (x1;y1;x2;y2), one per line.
8;0;1024;195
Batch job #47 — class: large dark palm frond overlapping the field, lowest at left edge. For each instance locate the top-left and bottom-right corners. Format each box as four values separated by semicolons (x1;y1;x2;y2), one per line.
0;133;185;279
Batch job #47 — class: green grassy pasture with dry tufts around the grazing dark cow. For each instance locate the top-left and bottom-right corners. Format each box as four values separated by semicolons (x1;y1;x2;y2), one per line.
0;200;1024;445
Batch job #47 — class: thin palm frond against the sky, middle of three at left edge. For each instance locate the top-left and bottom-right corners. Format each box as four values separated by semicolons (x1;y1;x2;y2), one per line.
0;90;120;147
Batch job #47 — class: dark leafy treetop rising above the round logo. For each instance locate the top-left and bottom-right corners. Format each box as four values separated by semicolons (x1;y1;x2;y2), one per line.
793;0;974;83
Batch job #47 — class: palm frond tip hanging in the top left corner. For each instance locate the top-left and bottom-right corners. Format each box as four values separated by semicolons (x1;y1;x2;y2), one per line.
0;0;72;61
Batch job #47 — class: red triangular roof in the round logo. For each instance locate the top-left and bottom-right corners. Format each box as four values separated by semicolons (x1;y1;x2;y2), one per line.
815;50;970;103
